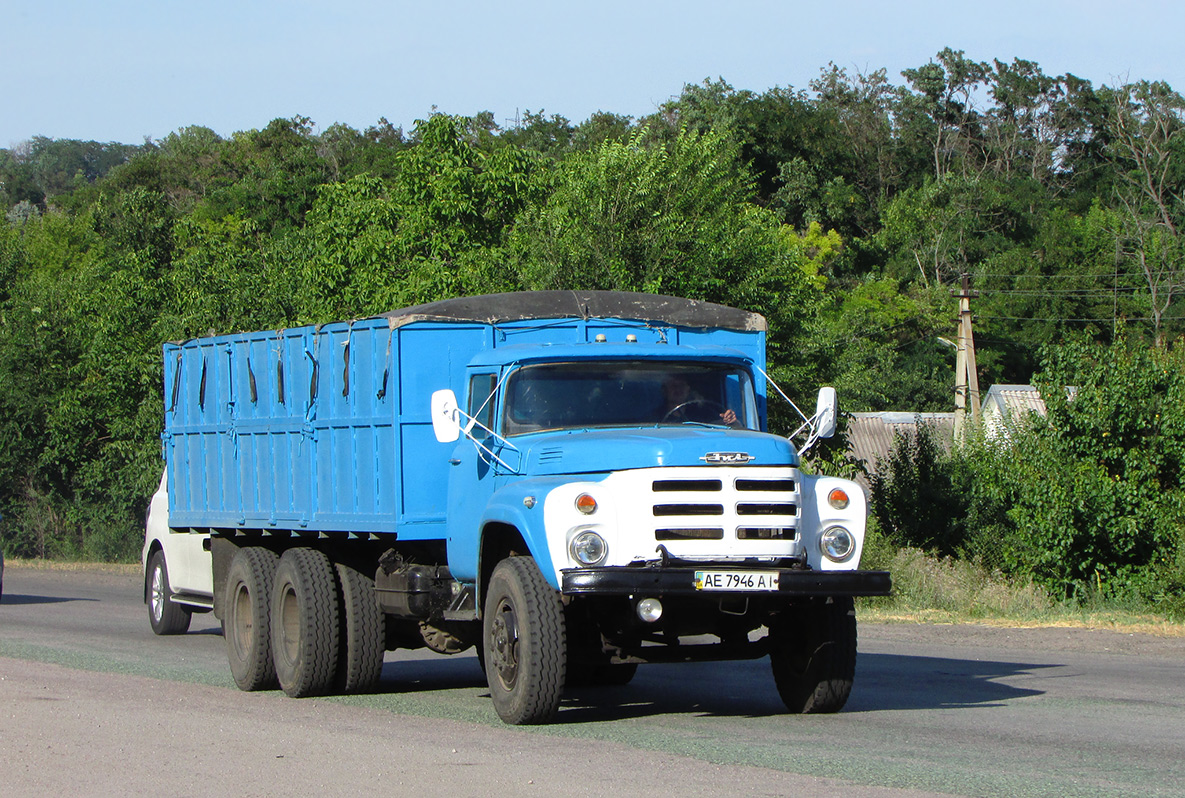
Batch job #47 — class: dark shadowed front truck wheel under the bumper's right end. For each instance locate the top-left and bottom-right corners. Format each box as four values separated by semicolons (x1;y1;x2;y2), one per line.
769;596;856;715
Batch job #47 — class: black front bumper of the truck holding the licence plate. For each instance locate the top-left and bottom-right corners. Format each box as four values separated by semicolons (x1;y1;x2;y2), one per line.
561;566;892;596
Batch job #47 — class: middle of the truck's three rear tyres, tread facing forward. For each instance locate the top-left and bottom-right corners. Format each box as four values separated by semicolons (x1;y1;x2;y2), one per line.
271;548;339;698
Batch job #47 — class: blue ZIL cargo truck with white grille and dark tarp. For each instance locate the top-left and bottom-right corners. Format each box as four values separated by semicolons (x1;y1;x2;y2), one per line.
162;291;890;723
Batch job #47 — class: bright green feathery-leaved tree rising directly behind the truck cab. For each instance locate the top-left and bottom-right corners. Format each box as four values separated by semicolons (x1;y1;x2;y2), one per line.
505;124;840;390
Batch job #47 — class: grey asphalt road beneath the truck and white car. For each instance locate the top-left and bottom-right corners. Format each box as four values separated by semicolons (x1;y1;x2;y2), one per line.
0;564;1185;798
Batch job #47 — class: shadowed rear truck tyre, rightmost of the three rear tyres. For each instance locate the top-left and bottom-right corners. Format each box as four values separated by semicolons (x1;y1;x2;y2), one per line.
338;562;386;692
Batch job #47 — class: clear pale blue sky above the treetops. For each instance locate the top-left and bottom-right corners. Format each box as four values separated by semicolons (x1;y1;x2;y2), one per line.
0;0;1185;147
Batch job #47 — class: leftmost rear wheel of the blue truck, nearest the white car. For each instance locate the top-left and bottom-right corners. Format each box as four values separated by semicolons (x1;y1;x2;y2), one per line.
223;545;280;691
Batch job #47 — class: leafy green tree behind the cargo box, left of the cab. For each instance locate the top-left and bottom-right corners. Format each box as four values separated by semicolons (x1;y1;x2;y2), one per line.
299;115;539;321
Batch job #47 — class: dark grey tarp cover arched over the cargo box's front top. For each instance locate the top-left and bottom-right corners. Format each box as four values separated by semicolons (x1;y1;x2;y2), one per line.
379;291;766;332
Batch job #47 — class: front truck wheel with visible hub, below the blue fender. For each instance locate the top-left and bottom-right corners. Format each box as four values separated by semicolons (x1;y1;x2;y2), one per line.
482;557;566;724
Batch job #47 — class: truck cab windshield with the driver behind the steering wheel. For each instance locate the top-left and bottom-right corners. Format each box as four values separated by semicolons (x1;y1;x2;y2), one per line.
502;360;758;435
